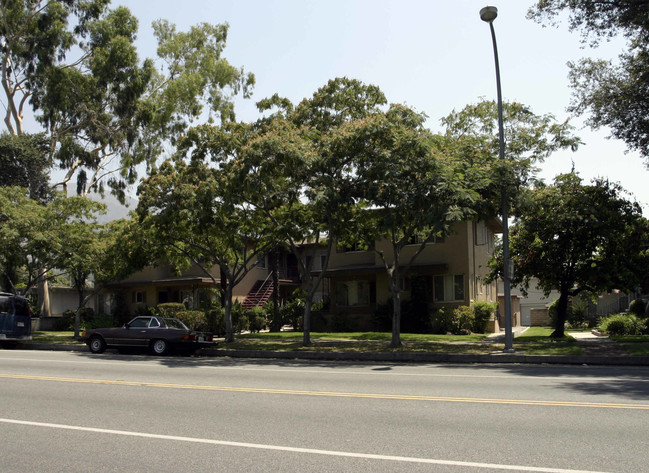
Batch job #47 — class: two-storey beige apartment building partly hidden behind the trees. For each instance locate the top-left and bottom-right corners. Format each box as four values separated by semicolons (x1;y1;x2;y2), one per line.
111;220;502;330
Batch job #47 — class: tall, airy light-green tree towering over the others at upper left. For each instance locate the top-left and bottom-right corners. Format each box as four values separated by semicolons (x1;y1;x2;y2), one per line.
0;0;254;197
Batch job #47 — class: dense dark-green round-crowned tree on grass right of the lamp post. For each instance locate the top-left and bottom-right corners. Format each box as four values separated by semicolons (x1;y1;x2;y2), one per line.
492;173;649;337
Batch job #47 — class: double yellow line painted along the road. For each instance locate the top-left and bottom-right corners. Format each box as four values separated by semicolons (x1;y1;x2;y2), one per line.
5;374;649;410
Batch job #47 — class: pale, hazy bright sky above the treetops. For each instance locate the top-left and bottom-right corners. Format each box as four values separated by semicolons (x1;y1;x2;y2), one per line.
113;0;649;210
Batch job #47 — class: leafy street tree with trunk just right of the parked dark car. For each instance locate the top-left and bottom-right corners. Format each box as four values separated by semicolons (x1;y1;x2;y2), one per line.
137;153;274;342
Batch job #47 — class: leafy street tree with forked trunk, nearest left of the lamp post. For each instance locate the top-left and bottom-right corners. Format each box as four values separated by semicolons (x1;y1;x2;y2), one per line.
331;105;478;348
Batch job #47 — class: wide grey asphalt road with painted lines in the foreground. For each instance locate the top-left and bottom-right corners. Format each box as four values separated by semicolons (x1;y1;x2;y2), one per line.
0;350;649;473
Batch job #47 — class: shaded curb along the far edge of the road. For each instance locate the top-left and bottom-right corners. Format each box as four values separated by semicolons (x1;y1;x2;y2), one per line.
19;343;649;366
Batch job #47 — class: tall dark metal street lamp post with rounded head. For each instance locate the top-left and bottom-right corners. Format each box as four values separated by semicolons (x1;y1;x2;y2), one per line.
480;6;514;353
